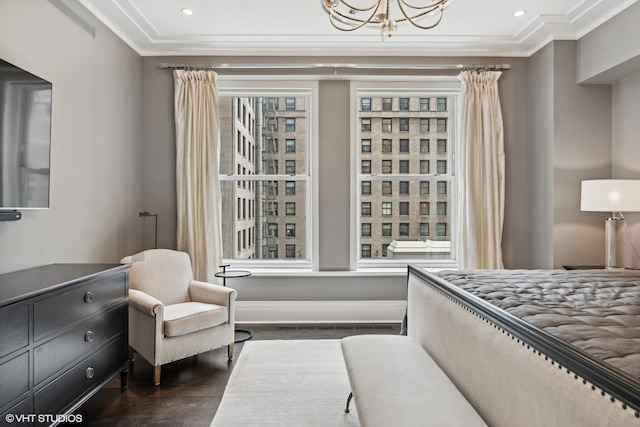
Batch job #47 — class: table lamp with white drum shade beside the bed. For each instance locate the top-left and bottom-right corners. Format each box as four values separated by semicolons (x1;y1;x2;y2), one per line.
580;179;640;268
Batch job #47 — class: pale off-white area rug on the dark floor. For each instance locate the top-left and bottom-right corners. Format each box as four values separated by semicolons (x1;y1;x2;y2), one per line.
211;340;359;427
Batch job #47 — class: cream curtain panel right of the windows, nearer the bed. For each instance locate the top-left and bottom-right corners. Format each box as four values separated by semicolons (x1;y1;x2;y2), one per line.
456;71;504;269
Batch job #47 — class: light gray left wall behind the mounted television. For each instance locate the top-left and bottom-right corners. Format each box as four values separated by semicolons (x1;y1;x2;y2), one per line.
0;0;142;273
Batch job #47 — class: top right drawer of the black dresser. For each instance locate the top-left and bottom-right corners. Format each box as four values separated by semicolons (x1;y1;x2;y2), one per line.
33;273;127;341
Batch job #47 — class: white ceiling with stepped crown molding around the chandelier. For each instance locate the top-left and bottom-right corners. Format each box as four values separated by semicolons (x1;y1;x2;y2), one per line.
78;0;637;56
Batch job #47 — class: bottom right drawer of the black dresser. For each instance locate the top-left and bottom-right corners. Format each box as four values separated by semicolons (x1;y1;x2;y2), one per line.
33;334;128;414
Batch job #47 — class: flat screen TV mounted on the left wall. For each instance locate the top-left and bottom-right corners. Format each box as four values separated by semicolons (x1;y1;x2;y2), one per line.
0;59;52;210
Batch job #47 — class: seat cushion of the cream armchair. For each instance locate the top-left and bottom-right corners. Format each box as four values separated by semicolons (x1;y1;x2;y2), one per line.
164;302;229;337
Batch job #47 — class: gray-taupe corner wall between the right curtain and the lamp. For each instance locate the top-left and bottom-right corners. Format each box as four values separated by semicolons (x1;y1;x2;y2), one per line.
529;41;611;268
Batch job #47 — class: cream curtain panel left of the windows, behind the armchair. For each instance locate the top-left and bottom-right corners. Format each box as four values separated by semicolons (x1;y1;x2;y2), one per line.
173;70;222;283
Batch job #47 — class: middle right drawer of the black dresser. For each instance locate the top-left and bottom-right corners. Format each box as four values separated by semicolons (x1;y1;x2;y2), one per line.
33;305;128;385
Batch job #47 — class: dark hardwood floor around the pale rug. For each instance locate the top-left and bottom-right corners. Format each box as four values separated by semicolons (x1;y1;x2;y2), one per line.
66;323;400;427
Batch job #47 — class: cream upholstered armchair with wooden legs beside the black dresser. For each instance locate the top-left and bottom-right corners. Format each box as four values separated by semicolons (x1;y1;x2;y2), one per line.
121;249;237;385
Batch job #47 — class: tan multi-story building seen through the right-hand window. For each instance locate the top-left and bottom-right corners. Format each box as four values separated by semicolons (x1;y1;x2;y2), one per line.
353;93;456;266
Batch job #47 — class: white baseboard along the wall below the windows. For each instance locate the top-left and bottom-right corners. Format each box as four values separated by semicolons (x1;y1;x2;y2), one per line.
236;301;407;324
